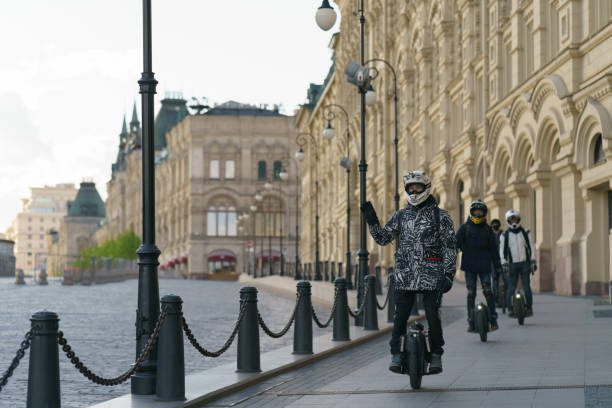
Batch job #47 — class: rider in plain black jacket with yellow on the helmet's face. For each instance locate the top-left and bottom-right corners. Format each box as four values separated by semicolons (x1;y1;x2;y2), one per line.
457;200;501;332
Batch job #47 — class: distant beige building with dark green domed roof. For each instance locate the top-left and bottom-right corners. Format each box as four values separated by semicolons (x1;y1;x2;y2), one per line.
47;181;105;275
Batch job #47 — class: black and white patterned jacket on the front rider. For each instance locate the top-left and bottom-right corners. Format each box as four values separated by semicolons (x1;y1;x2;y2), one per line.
369;196;457;291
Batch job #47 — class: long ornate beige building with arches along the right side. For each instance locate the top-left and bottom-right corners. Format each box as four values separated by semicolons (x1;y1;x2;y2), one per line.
297;0;612;294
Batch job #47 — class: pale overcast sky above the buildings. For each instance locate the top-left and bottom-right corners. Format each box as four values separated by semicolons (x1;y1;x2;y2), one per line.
0;0;338;232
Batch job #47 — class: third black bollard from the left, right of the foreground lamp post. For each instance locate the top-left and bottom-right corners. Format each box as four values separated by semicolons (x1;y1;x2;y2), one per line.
236;286;261;373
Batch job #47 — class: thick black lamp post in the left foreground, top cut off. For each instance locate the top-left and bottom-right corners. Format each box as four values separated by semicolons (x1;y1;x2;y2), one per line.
131;0;160;395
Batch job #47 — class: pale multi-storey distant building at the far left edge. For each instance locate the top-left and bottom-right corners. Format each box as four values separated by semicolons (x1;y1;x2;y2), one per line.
6;184;77;275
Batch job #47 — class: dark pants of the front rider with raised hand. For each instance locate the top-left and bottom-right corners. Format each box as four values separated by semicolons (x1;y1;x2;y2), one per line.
389;290;444;355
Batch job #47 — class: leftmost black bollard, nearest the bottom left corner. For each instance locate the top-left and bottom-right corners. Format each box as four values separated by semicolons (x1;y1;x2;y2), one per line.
26;310;62;408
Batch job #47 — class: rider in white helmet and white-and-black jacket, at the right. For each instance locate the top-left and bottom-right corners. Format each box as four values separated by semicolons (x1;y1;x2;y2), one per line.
499;210;538;316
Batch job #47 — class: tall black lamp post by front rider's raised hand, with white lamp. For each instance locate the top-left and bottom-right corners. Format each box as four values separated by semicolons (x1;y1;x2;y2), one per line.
316;0;369;326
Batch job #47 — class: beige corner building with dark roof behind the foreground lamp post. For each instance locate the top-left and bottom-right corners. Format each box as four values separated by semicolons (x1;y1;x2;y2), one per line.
104;98;298;279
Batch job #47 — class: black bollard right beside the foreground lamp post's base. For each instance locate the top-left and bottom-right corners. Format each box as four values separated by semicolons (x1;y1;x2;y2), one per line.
155;295;185;401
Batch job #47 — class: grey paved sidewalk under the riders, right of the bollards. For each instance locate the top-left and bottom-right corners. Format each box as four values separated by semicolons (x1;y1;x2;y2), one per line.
208;284;612;408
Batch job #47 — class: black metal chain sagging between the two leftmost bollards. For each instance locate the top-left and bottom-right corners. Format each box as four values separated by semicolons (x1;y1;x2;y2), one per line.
57;308;168;385
